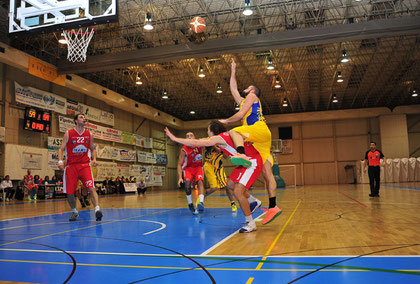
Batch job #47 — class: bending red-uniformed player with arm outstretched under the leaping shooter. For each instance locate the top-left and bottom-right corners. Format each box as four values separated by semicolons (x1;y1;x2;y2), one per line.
165;121;263;233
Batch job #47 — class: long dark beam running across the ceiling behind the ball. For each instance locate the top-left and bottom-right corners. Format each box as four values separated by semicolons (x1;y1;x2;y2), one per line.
58;16;420;74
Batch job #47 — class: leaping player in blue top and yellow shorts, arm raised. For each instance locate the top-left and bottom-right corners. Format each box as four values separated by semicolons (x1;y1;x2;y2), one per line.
220;59;282;225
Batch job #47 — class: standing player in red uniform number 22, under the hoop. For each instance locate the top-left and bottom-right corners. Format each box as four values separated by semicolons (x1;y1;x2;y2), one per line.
58;113;103;221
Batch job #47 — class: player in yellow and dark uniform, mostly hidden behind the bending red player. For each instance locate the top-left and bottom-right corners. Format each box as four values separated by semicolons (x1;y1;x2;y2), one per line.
204;146;238;212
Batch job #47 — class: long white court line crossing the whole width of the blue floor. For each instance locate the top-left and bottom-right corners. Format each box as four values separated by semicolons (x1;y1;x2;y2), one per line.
0;248;420;258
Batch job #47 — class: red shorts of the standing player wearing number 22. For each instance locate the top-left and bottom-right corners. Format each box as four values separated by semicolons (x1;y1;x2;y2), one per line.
63;163;95;194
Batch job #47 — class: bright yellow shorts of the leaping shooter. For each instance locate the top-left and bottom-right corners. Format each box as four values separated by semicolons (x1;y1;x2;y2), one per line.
232;121;273;165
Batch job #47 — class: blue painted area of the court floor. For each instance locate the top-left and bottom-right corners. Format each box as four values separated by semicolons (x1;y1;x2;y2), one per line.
0;208;420;284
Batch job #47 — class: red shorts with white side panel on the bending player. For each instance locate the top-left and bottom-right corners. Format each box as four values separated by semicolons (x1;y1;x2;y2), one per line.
229;155;263;189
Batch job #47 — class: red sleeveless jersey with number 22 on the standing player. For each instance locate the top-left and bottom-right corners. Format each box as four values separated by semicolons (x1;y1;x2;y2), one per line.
66;129;92;165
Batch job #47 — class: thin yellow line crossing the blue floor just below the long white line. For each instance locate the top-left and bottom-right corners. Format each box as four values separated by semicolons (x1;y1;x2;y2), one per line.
0;259;420;272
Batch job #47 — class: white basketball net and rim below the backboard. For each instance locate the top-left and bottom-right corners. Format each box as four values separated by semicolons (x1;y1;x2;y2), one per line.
63;28;95;62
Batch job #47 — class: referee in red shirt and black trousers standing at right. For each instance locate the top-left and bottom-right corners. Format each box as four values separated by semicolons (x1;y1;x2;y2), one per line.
363;142;385;197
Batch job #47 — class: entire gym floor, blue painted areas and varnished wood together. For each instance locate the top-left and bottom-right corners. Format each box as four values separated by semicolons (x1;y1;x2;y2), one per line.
0;183;420;284
